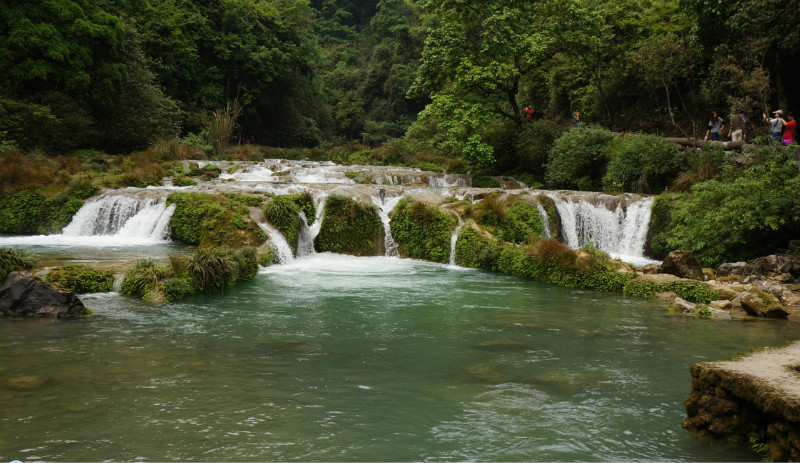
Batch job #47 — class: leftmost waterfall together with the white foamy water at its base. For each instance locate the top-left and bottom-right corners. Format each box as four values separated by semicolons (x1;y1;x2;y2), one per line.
0;189;175;247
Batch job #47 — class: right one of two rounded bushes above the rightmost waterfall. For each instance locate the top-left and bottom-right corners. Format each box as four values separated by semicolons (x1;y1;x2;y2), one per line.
603;134;686;193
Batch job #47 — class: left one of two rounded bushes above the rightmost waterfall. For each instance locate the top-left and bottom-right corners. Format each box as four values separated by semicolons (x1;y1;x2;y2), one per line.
545;127;614;191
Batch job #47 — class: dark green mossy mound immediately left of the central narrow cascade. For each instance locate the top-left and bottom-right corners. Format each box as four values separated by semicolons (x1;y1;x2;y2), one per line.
315;195;384;256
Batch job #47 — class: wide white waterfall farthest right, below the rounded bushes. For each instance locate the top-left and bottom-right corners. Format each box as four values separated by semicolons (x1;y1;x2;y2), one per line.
547;192;653;262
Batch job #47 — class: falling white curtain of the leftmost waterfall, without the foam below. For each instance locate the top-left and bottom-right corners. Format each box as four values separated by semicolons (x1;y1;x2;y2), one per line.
62;190;175;242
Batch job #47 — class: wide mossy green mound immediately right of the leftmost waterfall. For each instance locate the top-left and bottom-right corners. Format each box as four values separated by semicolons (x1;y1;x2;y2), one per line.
167;192;266;249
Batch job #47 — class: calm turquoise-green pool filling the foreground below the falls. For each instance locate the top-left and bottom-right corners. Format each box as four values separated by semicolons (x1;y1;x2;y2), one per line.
0;254;800;461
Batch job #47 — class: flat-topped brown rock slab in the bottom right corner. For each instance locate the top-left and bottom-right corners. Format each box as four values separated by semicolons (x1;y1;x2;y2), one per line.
683;341;800;461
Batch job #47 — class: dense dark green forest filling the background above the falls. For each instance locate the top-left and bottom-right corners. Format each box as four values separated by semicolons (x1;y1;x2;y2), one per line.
0;0;800;163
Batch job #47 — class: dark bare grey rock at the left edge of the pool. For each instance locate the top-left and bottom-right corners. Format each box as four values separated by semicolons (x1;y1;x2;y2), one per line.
0;272;89;318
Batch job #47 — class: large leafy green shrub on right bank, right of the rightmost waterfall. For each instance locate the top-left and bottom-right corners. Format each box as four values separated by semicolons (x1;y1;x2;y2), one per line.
659;149;800;267
